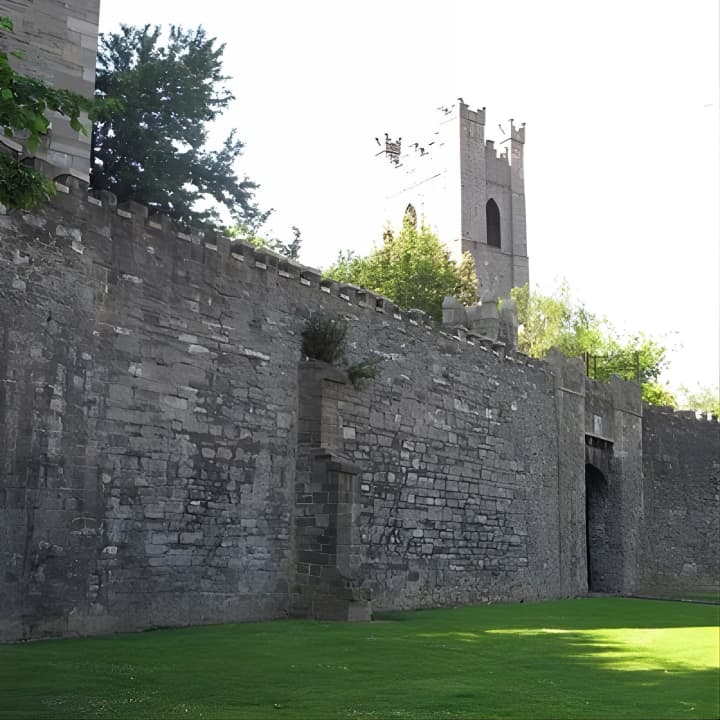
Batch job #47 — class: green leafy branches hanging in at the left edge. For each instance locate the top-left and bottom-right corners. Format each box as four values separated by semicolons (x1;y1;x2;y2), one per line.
0;16;102;210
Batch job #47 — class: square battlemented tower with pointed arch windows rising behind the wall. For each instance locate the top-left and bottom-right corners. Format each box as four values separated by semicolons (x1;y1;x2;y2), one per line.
378;99;529;298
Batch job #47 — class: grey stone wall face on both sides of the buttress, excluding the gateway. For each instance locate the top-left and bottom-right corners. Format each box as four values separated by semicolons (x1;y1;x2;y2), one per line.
0;189;582;638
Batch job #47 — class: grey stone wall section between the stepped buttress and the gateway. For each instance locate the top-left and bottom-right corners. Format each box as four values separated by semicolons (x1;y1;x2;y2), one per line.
337;325;564;608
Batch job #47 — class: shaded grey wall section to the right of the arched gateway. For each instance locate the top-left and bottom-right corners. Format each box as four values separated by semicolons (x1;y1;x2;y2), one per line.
641;405;720;594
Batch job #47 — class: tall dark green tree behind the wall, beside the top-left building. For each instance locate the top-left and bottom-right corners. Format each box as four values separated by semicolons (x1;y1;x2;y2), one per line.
90;25;260;227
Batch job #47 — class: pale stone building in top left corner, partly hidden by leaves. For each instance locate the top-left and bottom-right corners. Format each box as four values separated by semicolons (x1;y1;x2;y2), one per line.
0;0;100;181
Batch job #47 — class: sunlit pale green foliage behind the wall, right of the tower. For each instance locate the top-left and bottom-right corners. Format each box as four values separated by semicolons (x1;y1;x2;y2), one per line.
511;284;677;406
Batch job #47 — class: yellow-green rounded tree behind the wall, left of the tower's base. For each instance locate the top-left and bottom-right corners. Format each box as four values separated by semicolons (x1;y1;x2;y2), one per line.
324;215;477;320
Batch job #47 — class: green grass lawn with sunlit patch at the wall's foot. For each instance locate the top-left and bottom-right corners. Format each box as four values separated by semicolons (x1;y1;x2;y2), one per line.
0;598;720;720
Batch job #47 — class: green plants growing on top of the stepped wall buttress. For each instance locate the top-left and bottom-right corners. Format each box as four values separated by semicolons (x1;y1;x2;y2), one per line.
301;310;381;388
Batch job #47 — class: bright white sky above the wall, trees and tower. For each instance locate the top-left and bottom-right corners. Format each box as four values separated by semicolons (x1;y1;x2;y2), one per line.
100;0;720;394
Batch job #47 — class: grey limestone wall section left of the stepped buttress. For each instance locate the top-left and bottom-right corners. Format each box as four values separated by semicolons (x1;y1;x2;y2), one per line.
0;188;300;637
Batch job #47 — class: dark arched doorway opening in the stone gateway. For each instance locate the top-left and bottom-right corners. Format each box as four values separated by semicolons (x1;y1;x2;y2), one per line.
585;465;612;592
